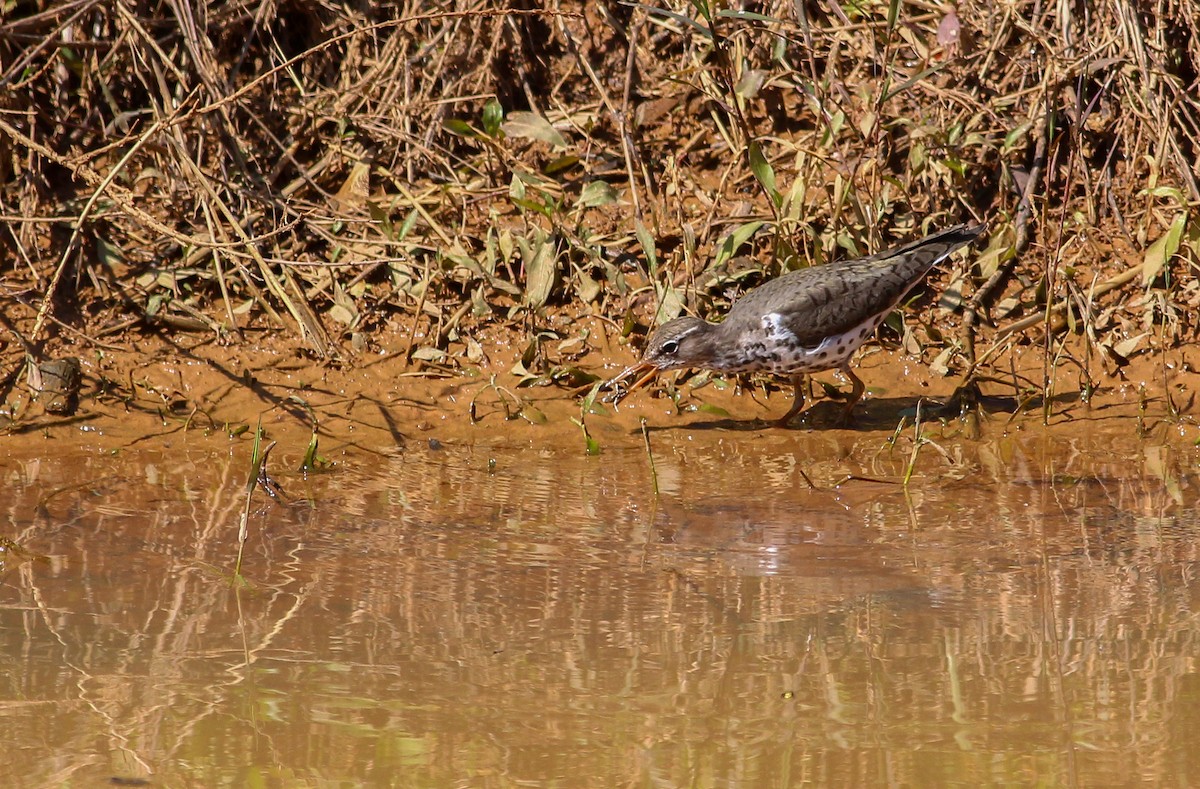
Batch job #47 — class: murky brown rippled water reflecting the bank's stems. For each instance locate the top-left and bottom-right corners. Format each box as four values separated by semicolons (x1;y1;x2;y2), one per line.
0;430;1200;787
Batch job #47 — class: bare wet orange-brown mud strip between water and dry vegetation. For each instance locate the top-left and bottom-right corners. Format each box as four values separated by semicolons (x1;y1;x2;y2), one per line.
4;321;1200;457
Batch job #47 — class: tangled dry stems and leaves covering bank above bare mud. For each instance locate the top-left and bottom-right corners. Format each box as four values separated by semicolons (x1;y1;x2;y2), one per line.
0;0;1200;414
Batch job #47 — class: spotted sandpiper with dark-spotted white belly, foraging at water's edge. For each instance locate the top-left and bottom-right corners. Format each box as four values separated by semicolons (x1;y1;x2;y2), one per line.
610;224;985;426
